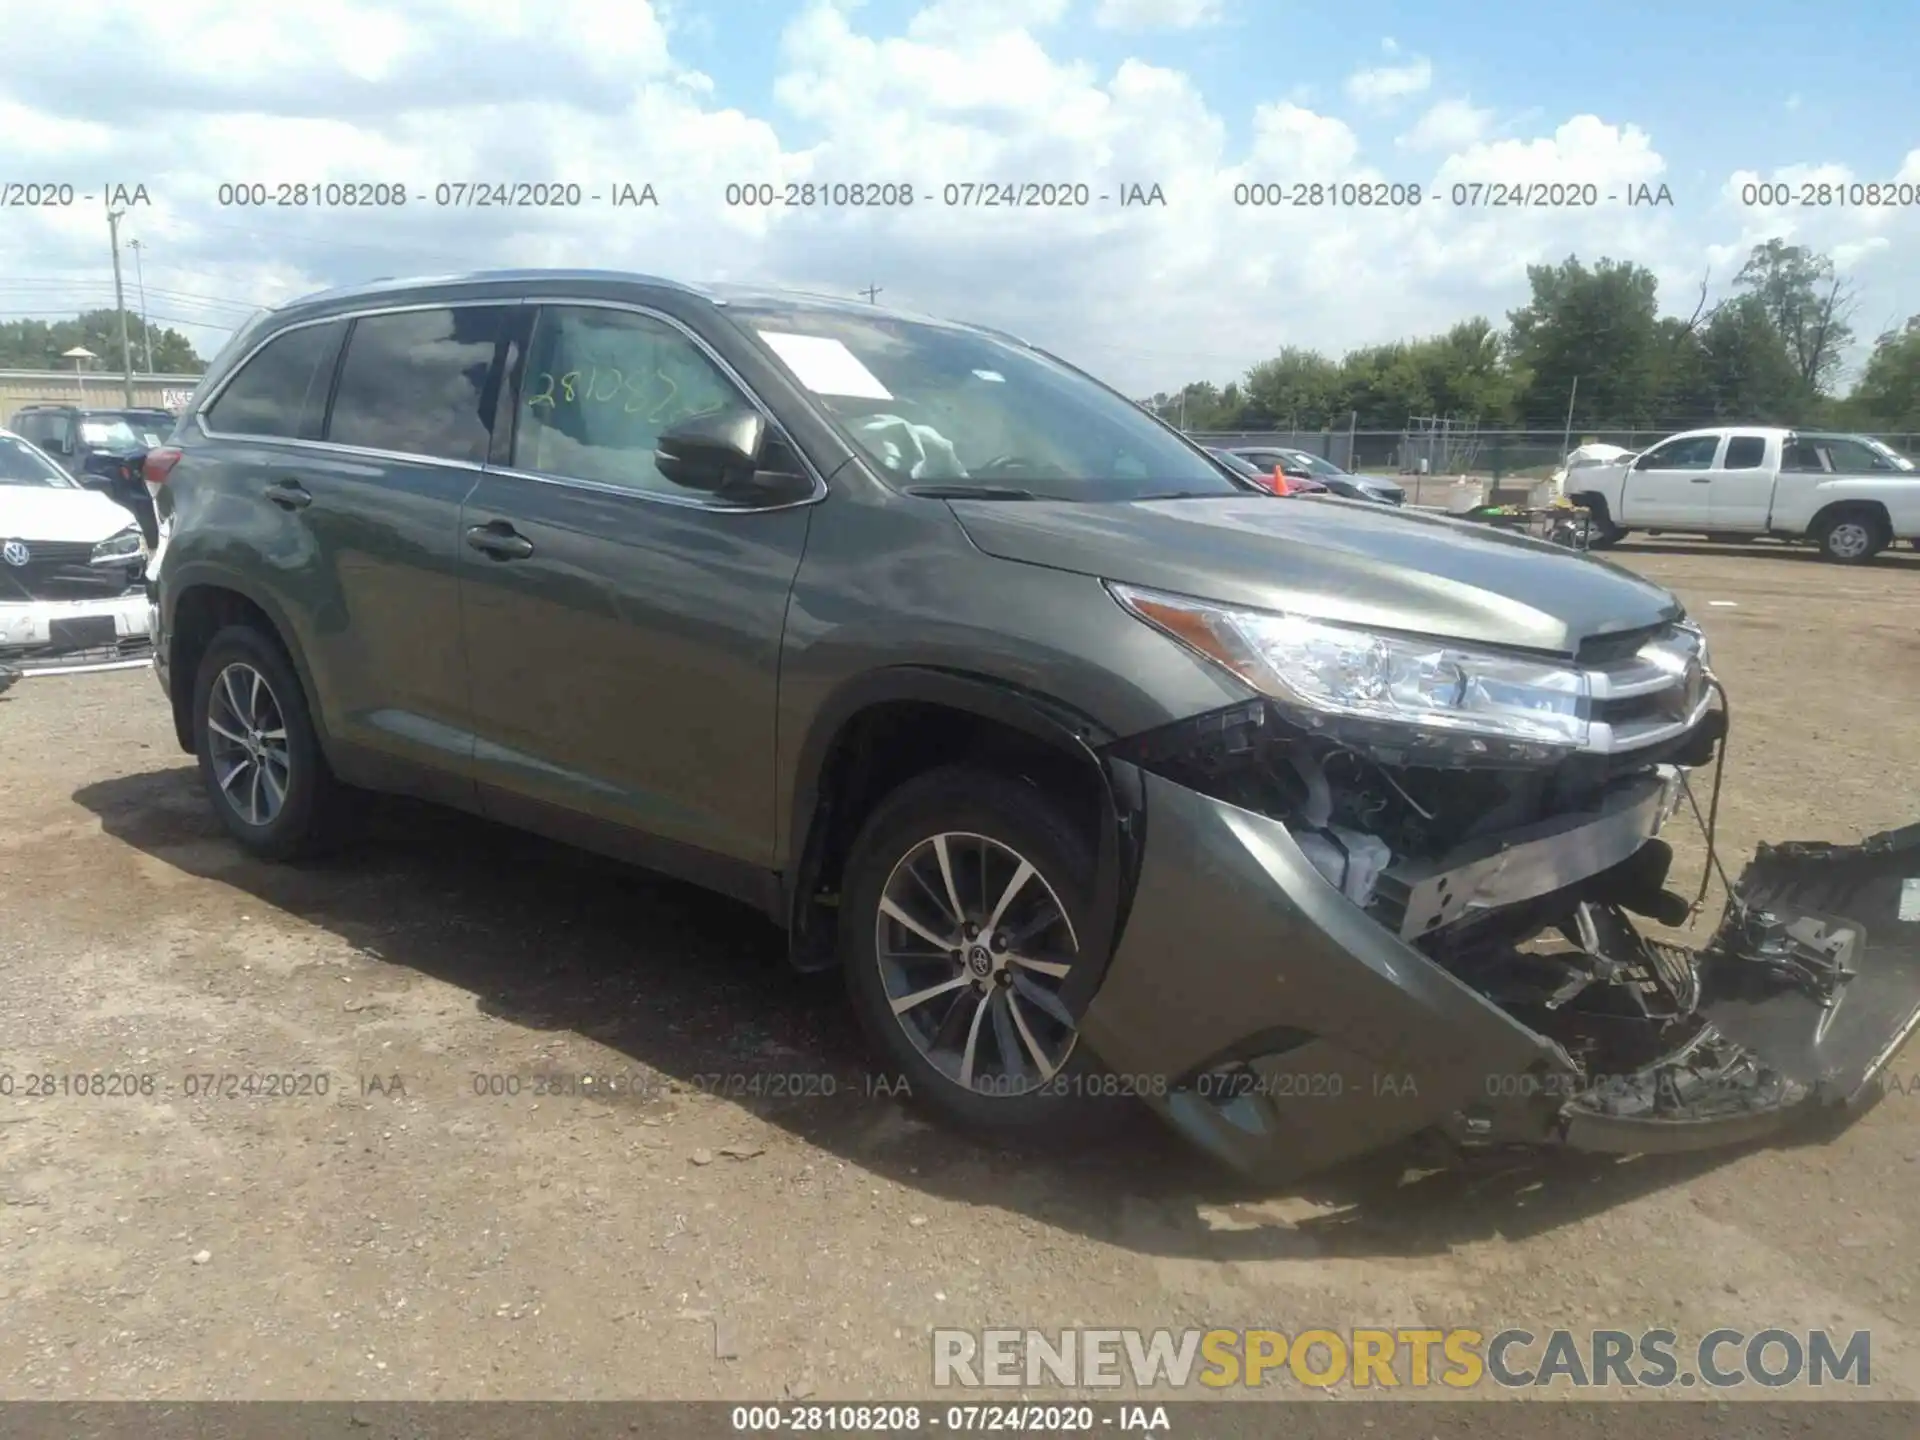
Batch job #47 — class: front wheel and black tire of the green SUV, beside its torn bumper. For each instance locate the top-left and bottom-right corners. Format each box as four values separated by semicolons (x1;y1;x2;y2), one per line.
841;766;1131;1146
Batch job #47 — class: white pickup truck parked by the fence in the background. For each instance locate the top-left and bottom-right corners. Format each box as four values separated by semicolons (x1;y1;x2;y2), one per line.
1567;426;1920;564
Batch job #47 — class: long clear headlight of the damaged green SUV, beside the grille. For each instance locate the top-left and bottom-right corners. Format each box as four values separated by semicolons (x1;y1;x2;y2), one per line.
1108;586;1592;749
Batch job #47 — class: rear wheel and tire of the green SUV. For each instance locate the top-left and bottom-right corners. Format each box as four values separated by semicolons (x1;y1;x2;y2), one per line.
194;624;348;860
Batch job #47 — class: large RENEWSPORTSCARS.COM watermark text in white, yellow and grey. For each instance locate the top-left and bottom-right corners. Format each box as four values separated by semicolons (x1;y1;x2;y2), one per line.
931;1327;1872;1390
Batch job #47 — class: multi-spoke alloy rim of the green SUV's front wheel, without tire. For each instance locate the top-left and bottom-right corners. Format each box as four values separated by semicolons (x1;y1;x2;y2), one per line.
874;831;1079;1096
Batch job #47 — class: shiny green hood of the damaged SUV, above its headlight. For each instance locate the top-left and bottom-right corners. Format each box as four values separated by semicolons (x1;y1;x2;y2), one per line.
950;495;1684;655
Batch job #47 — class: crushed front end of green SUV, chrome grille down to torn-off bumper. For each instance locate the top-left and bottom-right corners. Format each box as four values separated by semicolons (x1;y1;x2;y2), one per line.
1081;599;1920;1177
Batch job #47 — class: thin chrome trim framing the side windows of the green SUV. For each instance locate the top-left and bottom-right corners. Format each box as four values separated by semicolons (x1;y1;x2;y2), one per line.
194;292;828;515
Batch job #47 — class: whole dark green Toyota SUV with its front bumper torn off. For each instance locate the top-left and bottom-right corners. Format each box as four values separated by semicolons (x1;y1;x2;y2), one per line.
148;271;1920;1175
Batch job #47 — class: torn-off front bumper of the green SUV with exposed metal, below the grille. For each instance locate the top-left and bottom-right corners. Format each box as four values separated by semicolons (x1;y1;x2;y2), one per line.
1081;706;1920;1179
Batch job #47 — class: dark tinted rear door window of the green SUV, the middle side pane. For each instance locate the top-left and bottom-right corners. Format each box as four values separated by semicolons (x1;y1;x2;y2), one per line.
326;305;511;465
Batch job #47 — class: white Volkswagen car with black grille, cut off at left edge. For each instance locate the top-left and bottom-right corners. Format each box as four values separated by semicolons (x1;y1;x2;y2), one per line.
0;430;150;672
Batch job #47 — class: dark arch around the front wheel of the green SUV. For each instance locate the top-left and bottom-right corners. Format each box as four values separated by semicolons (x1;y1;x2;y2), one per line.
781;666;1140;1012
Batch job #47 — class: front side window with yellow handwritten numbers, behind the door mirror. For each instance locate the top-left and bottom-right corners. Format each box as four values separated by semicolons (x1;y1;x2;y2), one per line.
513;305;749;501
